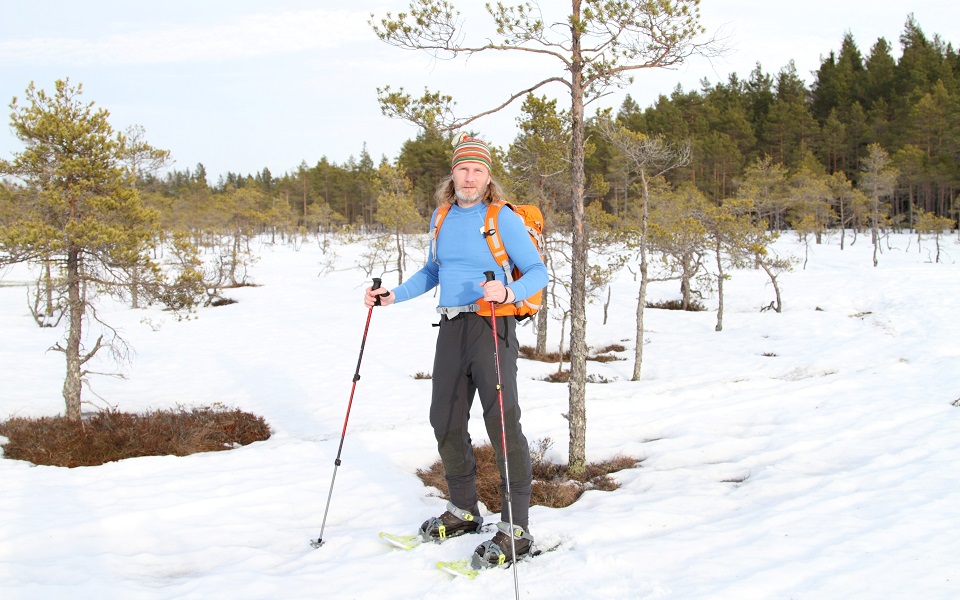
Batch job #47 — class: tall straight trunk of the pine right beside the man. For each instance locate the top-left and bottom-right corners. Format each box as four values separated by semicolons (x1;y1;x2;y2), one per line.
567;0;587;477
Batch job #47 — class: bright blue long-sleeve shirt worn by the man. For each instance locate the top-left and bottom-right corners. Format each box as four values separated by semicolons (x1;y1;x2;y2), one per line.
393;202;550;306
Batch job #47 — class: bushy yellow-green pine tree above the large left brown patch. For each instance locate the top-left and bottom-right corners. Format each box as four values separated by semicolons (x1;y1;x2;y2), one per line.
0;80;157;419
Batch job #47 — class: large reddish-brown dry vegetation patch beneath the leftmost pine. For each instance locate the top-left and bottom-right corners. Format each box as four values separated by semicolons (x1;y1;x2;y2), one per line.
0;407;270;467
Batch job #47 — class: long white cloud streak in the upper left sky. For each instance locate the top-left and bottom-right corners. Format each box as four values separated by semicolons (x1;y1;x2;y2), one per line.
0;10;372;66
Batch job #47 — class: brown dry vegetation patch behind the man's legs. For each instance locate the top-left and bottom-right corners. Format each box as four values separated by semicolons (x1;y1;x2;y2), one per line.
417;438;640;512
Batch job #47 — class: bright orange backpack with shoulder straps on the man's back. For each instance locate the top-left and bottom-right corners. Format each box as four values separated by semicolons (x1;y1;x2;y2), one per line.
432;201;543;321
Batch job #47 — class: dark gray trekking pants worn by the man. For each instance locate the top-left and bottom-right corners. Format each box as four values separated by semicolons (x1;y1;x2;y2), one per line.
430;313;532;529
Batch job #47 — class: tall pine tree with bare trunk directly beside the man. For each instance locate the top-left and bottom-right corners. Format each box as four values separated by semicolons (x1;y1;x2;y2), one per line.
374;0;715;476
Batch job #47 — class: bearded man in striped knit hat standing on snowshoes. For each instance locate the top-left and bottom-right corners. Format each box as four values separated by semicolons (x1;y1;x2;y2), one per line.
364;135;549;563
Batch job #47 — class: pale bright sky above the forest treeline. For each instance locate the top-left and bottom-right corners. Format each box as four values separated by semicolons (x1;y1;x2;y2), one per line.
0;0;960;183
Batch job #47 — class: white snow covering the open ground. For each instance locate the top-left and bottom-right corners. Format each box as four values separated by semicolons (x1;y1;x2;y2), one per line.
0;235;960;600
